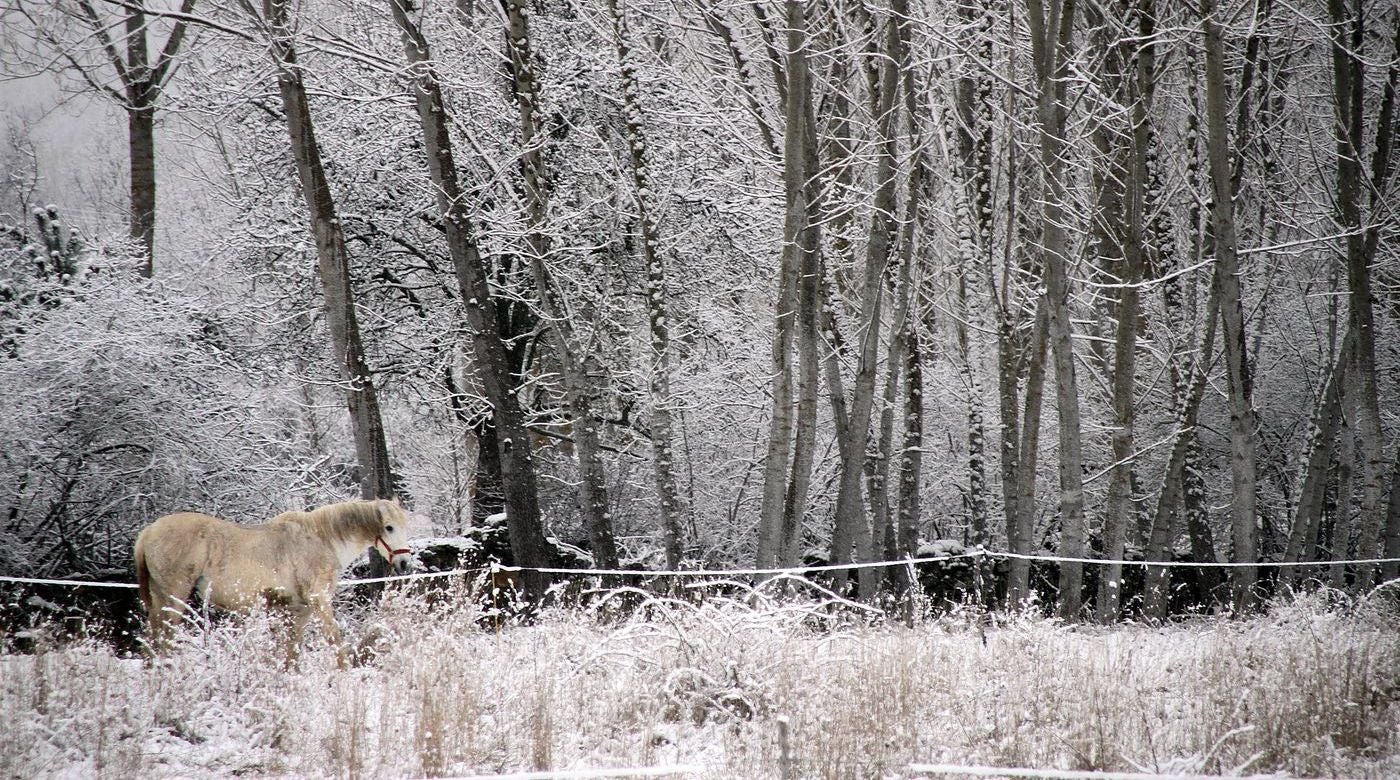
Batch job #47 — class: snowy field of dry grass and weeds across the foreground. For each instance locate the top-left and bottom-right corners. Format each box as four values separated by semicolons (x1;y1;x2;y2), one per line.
0;595;1400;779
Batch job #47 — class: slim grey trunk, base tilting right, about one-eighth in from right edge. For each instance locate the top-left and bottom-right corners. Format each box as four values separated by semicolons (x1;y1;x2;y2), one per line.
1201;0;1259;611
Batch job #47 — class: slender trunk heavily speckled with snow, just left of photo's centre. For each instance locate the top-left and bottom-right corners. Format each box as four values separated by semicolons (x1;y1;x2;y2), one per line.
608;0;683;571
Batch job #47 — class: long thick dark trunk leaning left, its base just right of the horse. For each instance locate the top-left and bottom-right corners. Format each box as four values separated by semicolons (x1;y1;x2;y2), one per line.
392;0;549;601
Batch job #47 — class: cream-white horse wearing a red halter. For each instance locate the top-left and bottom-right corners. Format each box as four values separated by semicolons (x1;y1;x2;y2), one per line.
134;500;410;665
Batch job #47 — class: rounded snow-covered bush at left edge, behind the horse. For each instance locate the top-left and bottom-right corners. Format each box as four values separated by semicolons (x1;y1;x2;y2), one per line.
0;263;309;576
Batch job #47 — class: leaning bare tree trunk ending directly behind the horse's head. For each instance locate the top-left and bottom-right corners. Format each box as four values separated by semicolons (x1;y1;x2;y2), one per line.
263;0;395;499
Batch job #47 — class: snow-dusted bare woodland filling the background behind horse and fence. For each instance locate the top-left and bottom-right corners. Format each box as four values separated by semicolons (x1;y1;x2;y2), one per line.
0;0;1400;619
